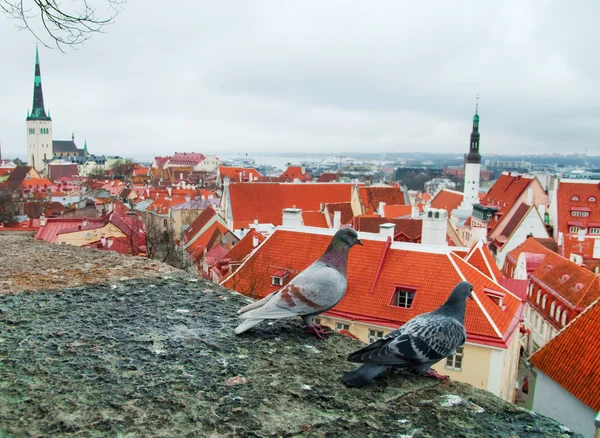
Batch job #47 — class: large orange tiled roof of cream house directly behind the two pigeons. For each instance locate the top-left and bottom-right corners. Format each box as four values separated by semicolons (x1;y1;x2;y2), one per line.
222;229;521;348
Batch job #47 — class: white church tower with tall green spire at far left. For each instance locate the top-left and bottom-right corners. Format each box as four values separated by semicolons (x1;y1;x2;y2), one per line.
26;47;54;172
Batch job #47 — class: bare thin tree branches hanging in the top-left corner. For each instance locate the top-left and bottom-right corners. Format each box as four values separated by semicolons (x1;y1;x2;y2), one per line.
0;0;126;51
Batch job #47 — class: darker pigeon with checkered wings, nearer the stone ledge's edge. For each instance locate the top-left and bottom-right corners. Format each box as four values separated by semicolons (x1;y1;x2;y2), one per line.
342;281;473;387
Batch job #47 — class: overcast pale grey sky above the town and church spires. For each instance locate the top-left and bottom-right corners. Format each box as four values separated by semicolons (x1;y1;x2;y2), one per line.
0;0;600;159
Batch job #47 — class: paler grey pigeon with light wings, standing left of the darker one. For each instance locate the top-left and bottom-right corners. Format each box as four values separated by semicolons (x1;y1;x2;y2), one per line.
235;228;362;339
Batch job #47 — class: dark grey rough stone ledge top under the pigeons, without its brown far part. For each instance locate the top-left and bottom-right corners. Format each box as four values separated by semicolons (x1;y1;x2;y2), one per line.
0;278;572;437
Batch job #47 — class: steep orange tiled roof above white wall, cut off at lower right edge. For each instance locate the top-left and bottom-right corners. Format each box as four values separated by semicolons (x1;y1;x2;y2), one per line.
529;302;600;412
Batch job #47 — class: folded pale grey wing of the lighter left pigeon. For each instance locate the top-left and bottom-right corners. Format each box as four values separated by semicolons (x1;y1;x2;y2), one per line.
240;261;346;319
